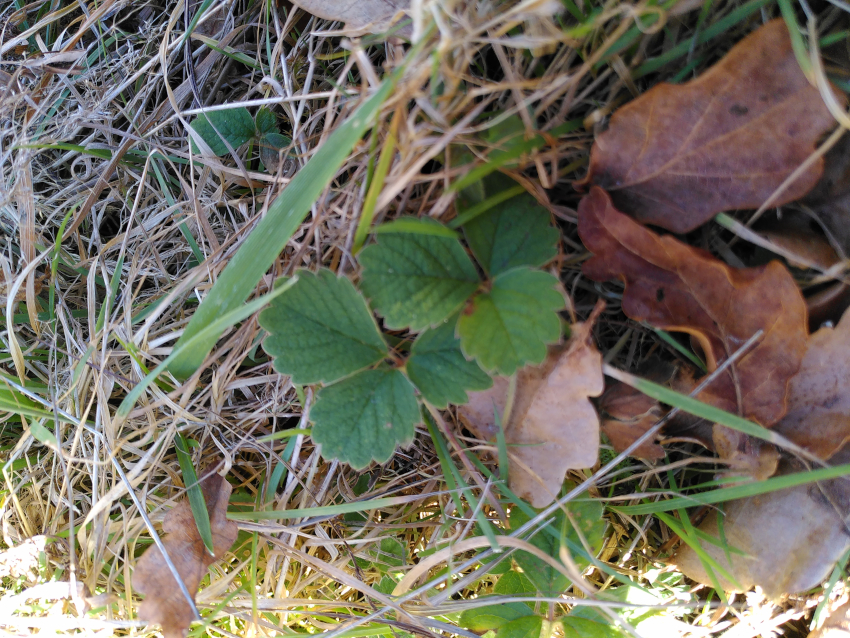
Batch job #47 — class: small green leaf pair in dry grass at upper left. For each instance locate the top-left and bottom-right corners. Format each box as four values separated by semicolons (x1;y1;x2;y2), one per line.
190;107;292;166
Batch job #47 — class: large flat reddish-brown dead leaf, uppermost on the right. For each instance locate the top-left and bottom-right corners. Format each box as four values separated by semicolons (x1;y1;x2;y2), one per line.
579;18;846;233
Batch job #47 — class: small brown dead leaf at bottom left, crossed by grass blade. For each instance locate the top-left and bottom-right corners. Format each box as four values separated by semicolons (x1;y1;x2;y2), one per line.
133;474;239;638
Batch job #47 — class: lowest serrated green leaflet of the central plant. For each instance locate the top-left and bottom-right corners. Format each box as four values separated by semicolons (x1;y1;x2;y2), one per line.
308;368;421;469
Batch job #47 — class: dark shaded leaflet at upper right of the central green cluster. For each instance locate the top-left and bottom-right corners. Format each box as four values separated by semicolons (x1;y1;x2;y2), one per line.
463;194;558;276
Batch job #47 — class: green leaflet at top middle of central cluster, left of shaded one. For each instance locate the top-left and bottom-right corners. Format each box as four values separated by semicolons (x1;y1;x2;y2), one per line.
359;222;480;331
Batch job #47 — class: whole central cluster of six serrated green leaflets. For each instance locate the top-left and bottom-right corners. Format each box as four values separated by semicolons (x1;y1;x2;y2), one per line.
260;197;564;468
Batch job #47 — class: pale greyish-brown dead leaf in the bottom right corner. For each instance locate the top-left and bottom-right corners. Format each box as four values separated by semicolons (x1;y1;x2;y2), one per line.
672;460;850;598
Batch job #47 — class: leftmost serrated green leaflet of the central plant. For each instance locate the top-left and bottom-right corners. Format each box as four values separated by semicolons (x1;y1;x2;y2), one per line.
260;269;388;385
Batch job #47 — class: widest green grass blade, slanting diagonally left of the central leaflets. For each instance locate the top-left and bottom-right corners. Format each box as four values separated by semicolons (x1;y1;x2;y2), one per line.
169;78;398;379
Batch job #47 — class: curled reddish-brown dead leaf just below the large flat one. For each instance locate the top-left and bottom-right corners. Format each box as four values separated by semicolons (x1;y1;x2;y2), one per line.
578;187;807;426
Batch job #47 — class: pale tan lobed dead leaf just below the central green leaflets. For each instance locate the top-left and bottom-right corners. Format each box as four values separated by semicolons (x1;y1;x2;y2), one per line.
458;302;604;507
